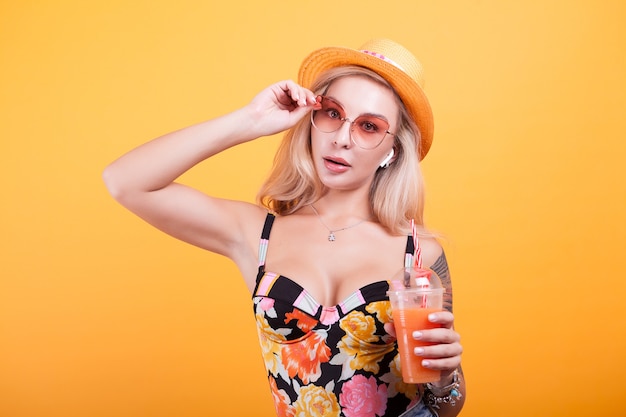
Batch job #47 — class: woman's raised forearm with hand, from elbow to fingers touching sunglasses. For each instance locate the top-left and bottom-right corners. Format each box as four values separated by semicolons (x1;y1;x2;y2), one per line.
104;81;316;200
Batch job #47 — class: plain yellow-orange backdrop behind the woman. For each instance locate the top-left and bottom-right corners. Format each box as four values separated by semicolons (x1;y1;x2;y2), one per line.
0;0;626;417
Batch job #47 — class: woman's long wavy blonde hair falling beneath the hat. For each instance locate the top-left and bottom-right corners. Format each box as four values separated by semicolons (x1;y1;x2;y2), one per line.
257;66;429;235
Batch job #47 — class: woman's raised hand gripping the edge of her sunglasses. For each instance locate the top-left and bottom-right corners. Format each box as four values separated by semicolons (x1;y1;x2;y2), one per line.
246;80;316;137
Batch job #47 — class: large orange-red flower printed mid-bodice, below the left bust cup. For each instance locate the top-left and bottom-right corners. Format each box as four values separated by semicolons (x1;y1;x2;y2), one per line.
282;330;331;384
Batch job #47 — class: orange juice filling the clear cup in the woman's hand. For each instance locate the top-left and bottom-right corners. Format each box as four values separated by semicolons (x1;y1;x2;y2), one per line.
393;307;441;384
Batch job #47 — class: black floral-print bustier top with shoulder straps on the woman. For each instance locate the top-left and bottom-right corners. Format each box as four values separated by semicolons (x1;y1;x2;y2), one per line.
253;213;431;417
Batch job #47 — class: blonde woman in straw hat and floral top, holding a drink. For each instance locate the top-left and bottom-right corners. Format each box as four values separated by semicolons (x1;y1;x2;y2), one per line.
104;40;465;417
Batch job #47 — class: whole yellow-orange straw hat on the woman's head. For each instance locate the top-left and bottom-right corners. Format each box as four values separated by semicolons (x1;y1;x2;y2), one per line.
298;39;434;160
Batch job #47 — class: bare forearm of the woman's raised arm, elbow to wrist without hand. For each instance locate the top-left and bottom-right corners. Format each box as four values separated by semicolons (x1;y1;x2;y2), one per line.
103;108;254;198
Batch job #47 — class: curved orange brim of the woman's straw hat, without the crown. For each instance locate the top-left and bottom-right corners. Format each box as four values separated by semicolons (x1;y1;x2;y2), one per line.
298;47;434;160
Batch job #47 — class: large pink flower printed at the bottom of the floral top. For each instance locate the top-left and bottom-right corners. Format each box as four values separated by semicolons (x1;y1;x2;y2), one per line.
339;375;387;417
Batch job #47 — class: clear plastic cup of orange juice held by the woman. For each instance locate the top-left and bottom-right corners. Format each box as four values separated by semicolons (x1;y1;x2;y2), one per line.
387;268;445;384
